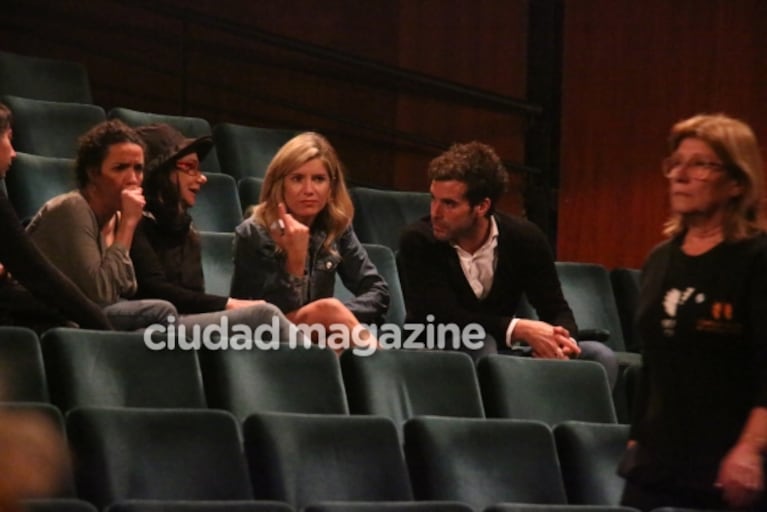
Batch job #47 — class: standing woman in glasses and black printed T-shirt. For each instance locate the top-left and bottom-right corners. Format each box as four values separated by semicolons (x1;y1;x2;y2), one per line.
620;115;767;510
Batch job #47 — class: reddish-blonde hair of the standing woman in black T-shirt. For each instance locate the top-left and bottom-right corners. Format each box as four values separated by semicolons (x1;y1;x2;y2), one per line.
663;114;764;241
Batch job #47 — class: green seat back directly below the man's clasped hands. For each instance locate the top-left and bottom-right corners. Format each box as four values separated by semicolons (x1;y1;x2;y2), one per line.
477;354;617;426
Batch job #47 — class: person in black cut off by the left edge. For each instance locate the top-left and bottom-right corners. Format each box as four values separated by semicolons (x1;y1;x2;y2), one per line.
0;103;111;332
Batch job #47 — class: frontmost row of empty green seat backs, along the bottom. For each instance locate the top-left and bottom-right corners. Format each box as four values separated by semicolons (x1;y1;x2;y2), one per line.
7;404;628;511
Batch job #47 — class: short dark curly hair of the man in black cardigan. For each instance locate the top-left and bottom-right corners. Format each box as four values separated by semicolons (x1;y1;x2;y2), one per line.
428;141;509;215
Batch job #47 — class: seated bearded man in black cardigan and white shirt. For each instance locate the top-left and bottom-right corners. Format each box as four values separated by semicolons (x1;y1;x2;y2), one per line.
398;142;618;384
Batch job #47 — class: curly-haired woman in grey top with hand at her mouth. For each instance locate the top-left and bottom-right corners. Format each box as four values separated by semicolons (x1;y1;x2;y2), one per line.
27;120;177;330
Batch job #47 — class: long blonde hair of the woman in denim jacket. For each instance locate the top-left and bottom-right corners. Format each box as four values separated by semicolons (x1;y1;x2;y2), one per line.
252;132;354;250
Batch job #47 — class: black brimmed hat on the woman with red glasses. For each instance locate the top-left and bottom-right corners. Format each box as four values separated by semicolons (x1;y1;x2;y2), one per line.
136;123;213;175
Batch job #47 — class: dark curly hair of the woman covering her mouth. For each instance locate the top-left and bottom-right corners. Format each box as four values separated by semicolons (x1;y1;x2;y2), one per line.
75;119;146;189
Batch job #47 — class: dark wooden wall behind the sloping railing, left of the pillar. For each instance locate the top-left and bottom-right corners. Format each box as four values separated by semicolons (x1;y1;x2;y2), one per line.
0;0;526;197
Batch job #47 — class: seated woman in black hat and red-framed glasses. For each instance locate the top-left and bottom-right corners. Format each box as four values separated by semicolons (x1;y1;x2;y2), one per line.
130;124;303;342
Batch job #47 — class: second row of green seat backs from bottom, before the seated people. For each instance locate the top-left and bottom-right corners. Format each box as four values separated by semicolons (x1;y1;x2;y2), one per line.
0;327;617;430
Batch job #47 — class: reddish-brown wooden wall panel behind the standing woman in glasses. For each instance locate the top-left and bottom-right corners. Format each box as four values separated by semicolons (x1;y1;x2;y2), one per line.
557;0;767;267
